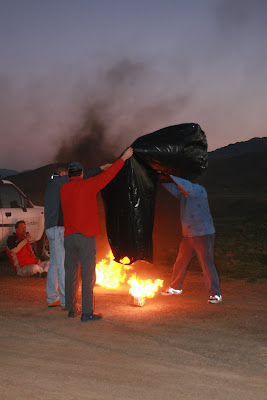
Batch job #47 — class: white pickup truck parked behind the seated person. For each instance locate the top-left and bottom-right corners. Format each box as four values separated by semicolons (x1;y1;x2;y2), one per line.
0;180;50;260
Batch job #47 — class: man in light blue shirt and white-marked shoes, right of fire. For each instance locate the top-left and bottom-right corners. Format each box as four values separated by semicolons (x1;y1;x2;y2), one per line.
162;176;222;304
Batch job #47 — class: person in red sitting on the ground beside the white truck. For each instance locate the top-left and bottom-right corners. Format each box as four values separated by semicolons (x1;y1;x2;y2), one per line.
6;221;49;278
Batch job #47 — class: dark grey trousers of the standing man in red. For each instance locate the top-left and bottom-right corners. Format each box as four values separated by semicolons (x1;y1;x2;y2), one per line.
64;233;96;314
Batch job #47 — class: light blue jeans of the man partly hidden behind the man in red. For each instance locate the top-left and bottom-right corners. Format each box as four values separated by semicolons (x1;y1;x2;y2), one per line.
45;226;65;307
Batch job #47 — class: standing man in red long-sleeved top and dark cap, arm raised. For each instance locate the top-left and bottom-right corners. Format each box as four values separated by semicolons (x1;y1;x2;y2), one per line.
60;147;133;322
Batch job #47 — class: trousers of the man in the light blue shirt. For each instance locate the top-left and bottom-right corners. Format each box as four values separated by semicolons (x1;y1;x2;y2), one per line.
170;234;221;296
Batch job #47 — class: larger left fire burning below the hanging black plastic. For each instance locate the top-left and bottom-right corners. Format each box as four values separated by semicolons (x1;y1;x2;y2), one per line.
96;250;132;288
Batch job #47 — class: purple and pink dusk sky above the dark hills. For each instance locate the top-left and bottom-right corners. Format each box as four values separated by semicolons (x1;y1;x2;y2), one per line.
0;0;267;171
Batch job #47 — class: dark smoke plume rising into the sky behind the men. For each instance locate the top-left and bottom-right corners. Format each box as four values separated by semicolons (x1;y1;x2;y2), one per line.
54;59;192;168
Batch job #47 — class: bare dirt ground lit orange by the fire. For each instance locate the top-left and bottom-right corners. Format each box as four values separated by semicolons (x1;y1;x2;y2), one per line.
0;260;267;400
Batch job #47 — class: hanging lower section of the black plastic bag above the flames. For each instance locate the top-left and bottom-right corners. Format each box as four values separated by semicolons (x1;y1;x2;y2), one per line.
101;157;158;264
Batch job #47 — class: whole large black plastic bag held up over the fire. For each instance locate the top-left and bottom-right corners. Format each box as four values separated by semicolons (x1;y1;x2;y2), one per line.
102;124;207;263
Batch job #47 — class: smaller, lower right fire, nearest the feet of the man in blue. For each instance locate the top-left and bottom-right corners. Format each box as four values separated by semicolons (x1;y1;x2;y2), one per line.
127;274;163;298
